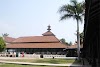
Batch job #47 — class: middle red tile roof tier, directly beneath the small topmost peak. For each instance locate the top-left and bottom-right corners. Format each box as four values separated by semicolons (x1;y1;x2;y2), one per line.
13;36;59;42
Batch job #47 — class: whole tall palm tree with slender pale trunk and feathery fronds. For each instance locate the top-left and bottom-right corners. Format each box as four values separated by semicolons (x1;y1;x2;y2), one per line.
59;0;84;60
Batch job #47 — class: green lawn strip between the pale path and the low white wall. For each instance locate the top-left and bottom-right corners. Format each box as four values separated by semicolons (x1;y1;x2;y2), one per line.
0;59;75;64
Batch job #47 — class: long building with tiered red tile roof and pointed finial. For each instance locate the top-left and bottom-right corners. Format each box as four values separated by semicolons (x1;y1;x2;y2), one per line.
4;26;68;55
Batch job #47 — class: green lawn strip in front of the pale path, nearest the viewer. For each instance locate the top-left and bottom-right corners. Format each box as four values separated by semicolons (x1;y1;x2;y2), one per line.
0;64;67;67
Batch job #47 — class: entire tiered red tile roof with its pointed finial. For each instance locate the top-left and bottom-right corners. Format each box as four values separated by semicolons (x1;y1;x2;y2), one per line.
5;25;72;48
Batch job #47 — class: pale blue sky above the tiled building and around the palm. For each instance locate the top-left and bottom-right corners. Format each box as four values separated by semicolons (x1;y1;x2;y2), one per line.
0;0;84;43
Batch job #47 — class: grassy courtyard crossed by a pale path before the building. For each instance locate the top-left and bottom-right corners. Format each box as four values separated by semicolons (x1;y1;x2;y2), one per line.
0;57;81;67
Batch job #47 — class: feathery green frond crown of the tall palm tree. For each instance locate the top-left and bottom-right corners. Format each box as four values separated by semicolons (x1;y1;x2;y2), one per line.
59;0;85;21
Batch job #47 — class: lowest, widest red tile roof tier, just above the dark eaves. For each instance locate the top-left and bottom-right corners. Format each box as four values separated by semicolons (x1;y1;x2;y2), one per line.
6;43;67;48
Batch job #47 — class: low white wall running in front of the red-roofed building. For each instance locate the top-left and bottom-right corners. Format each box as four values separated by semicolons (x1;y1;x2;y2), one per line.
0;54;76;59
